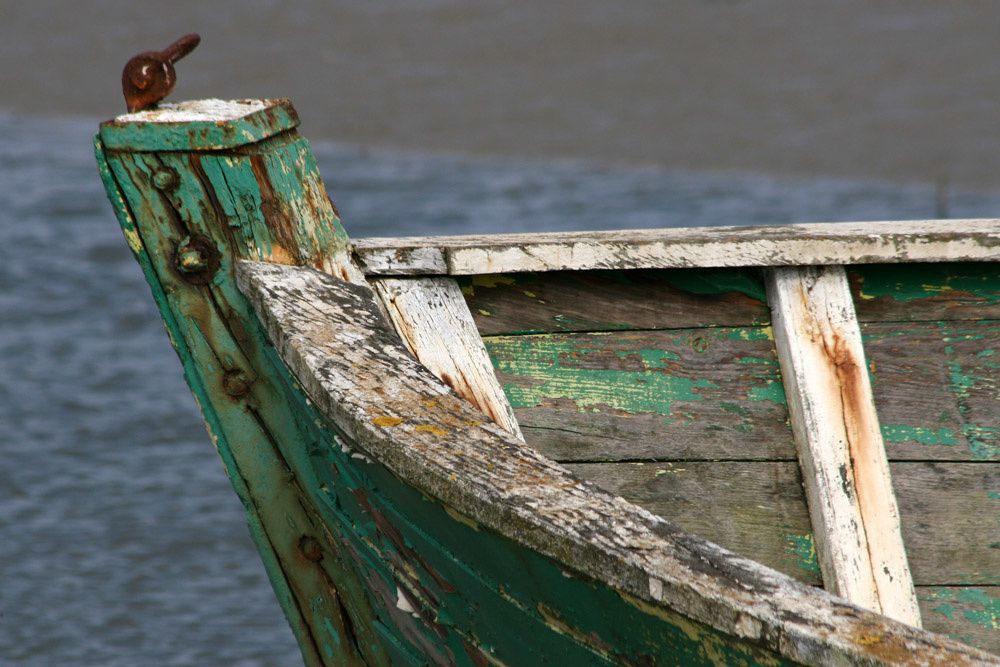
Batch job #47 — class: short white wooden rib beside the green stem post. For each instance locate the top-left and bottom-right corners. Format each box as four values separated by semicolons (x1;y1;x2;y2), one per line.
372;278;523;439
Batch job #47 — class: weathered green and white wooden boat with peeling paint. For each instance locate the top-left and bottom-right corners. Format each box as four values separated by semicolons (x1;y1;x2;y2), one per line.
96;100;1000;665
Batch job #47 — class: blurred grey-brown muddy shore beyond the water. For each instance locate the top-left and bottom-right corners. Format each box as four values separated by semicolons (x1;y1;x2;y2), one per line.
0;0;1000;190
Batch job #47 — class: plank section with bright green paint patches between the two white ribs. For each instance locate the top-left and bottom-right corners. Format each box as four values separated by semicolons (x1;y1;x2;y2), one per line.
484;327;795;461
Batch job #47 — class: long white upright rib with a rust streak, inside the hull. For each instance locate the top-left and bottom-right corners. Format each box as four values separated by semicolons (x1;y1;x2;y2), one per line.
768;267;920;625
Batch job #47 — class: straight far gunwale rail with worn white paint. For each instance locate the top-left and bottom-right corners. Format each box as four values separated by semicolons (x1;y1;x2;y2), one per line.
354;219;1000;275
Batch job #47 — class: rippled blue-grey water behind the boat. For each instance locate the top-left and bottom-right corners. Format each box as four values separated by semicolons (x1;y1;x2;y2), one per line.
0;115;1000;665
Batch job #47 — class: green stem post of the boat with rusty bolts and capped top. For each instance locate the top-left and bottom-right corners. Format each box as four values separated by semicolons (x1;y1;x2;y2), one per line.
95;100;390;665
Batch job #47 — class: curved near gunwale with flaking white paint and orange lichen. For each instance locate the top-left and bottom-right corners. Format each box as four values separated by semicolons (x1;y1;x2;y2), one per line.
237;262;1000;665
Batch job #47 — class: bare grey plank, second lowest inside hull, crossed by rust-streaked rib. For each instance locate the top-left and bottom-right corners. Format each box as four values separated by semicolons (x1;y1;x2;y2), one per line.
567;461;1000;586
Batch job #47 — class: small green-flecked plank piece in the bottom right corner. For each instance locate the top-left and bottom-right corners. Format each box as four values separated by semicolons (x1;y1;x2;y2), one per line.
917;586;1000;655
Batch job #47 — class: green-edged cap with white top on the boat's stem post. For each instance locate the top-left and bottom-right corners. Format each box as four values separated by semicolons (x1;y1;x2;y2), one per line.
100;99;299;151
